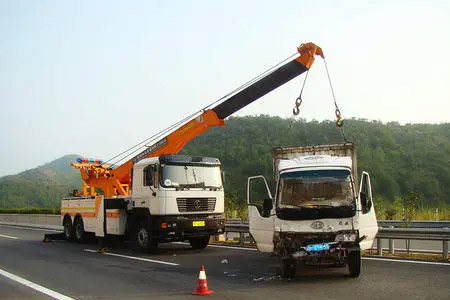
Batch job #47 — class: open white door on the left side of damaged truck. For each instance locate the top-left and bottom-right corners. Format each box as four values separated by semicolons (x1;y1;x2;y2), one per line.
247;175;275;252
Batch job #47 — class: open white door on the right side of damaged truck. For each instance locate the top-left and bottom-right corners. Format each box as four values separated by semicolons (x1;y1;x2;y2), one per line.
358;171;378;250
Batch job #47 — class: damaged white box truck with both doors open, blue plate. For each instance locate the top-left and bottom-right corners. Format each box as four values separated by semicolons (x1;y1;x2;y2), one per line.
247;143;378;278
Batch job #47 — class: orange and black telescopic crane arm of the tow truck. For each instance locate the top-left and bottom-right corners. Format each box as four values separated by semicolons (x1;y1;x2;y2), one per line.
72;43;324;197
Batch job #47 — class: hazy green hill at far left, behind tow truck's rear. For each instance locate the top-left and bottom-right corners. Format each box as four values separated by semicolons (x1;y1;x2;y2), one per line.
0;155;81;208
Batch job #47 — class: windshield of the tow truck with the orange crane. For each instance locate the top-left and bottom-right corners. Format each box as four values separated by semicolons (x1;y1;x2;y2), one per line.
161;164;222;188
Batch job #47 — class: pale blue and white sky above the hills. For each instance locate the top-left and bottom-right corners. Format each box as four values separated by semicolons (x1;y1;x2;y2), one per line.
0;0;450;176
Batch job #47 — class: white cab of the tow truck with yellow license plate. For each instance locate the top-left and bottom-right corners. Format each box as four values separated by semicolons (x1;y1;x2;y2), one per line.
129;155;225;243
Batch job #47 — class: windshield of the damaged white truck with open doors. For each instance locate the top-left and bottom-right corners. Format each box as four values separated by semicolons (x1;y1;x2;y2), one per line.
278;170;354;208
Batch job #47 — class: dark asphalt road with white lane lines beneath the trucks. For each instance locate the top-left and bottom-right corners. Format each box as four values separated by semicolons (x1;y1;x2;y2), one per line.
0;226;450;300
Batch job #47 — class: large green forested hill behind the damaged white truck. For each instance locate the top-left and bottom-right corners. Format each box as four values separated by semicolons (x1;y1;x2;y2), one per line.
182;116;450;205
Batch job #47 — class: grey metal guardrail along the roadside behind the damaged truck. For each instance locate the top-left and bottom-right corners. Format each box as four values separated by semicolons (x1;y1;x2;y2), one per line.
225;220;450;260
